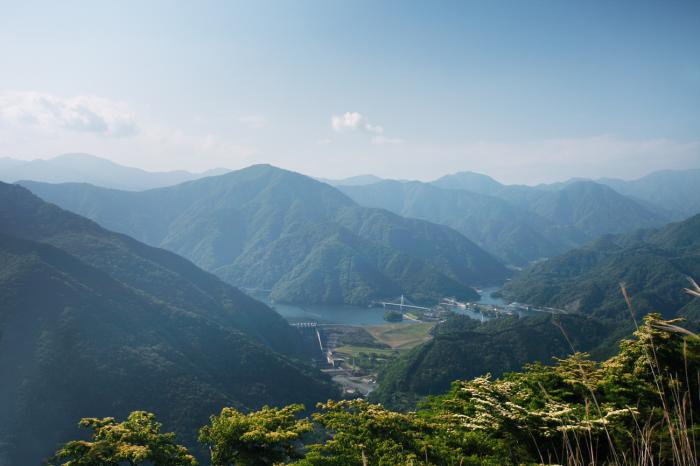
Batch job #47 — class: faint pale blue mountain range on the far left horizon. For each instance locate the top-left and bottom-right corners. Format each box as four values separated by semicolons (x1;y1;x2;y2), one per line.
0;154;228;191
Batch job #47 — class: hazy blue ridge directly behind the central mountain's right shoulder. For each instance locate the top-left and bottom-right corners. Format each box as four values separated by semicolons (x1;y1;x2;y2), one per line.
339;181;586;266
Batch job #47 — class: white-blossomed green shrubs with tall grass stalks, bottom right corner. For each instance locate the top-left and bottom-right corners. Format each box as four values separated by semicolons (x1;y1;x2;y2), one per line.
423;315;700;464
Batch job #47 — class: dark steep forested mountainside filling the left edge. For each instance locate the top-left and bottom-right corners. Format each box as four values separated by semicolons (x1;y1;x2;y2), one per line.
0;183;337;464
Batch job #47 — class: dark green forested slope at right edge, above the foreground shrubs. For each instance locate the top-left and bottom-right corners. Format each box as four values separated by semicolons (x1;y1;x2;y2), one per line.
502;215;700;318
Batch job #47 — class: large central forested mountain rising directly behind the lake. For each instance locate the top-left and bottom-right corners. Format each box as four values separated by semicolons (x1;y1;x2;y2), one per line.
23;165;509;304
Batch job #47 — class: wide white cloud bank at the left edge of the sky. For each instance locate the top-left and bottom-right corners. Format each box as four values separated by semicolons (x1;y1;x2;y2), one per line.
0;92;138;137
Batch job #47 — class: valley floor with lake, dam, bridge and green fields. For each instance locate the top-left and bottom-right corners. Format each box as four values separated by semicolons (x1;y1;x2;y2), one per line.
262;287;566;397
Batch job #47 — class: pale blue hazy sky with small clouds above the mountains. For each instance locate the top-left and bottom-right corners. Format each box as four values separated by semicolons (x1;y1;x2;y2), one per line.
0;0;700;183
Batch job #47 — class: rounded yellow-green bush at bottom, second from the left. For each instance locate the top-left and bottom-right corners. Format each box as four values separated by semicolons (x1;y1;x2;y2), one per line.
199;405;311;466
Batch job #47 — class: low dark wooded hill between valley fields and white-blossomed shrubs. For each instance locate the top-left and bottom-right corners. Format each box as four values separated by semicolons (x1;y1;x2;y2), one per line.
372;315;608;407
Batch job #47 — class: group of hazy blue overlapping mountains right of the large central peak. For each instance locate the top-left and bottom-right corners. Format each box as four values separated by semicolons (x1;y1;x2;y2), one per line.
339;178;668;266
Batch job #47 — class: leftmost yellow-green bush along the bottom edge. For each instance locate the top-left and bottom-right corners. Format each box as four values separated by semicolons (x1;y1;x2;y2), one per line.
54;411;197;466
